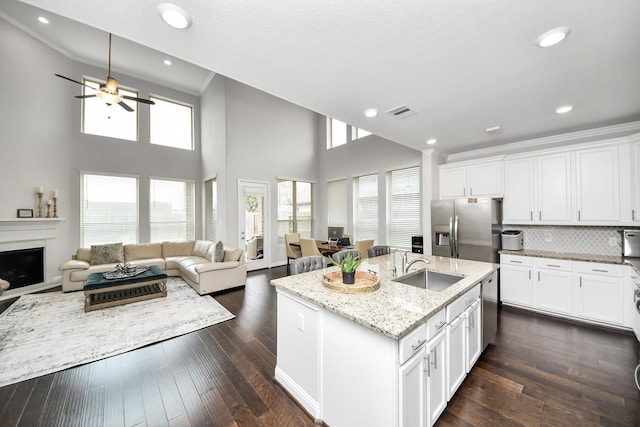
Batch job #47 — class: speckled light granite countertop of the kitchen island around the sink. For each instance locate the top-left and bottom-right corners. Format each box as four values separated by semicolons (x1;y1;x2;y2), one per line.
271;254;499;339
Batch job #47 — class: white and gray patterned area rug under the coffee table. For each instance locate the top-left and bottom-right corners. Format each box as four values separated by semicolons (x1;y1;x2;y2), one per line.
0;277;234;386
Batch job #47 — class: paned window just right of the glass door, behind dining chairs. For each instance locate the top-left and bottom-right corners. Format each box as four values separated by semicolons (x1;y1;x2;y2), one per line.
278;179;313;245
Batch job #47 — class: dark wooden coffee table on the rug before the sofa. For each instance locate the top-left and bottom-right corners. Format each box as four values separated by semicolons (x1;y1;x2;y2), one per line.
84;265;167;313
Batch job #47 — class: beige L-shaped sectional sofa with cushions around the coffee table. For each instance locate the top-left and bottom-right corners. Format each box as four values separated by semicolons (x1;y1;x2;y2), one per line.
59;240;247;295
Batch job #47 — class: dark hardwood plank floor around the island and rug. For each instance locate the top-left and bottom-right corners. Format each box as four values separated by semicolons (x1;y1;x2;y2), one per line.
0;267;640;427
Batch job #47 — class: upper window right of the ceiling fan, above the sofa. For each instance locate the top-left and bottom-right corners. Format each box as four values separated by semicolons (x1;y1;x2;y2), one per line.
149;97;193;150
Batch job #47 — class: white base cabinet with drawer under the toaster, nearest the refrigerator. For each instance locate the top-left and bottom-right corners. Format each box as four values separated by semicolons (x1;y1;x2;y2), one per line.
500;255;534;307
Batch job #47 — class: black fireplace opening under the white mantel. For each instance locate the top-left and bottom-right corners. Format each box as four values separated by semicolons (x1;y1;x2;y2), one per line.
0;248;44;289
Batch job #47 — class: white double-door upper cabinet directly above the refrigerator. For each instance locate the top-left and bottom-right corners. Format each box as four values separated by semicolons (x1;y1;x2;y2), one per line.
440;160;503;199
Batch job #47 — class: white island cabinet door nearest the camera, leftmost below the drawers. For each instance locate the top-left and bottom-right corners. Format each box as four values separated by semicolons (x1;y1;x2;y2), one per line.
399;347;427;427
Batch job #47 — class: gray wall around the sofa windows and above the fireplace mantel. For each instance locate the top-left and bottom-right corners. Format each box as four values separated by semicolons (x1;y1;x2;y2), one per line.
0;19;202;279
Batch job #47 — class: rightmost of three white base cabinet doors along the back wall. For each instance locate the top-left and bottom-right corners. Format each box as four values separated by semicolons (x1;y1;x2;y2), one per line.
578;274;624;325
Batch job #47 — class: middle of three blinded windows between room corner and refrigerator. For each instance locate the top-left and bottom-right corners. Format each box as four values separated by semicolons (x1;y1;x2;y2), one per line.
353;174;378;240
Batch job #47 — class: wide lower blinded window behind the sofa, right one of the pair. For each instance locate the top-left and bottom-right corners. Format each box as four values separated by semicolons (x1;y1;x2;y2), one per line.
149;179;195;242
